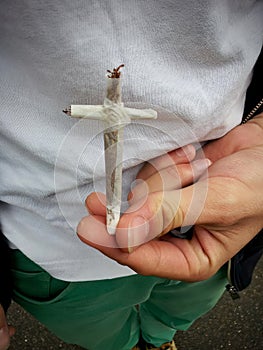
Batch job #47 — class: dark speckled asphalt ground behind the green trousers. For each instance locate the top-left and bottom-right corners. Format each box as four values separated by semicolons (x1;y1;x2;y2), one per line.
8;258;263;350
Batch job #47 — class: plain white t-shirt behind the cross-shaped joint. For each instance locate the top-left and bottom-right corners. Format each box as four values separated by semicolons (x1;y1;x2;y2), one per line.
0;0;263;281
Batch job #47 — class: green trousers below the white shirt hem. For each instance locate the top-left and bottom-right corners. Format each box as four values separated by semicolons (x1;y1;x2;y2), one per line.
12;250;227;350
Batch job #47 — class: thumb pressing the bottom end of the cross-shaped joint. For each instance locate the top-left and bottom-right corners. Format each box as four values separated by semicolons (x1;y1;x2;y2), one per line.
116;180;207;252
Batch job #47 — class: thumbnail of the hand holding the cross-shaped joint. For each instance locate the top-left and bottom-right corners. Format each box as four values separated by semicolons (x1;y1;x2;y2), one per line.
128;216;149;253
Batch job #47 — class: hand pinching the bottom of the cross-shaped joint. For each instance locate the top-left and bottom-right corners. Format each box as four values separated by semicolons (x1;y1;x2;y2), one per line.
77;114;263;281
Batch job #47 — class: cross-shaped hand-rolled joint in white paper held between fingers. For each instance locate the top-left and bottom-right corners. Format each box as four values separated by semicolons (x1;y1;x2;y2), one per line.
63;64;157;235
